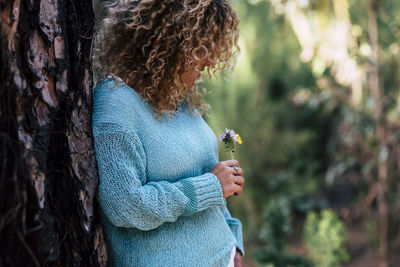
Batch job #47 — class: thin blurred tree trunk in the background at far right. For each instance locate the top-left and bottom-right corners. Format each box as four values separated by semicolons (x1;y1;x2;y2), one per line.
368;0;389;267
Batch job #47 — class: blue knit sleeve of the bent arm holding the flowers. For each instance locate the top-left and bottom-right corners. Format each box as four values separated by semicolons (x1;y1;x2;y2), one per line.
93;123;224;231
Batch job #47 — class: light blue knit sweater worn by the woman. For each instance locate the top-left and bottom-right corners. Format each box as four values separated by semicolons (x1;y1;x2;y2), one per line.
92;79;244;267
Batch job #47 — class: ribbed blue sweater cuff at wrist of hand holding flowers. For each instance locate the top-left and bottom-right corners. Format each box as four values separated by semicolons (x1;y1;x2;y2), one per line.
179;172;225;216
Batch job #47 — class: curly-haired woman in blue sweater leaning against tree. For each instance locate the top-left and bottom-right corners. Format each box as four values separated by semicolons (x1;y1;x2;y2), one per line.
92;0;244;267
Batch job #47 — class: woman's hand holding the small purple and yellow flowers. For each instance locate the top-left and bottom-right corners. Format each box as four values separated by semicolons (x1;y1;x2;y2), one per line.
211;160;244;198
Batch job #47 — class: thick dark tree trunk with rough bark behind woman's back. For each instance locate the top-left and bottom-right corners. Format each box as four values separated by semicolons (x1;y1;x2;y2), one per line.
0;0;106;267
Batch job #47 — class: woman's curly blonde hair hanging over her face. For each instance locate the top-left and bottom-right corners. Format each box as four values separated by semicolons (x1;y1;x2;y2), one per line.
95;0;240;117
